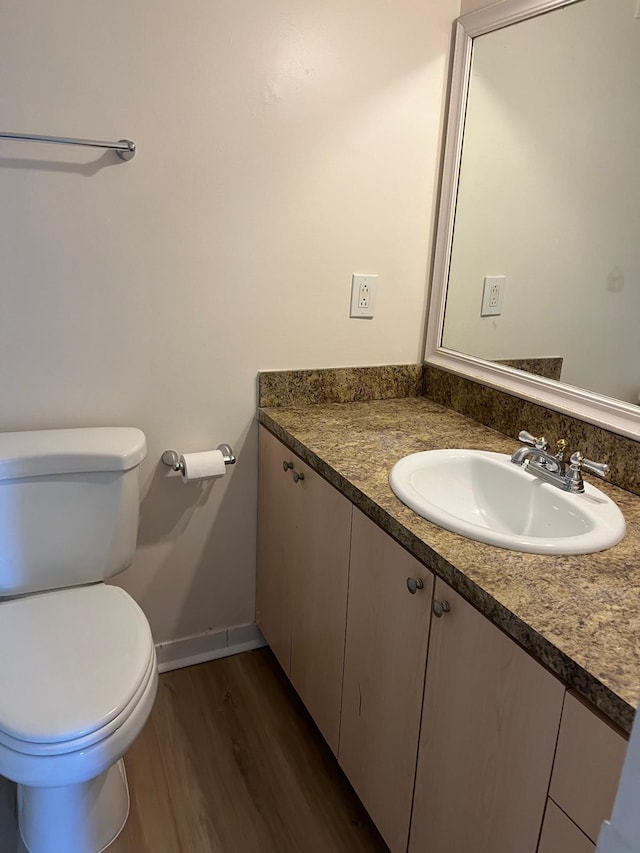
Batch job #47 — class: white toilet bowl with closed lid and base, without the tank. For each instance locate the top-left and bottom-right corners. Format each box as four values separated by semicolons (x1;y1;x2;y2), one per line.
0;583;157;853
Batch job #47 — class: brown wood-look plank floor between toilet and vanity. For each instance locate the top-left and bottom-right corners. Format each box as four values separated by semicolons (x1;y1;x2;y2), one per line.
0;649;388;853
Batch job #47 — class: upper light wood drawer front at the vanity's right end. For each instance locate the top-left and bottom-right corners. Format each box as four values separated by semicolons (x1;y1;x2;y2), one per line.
549;693;627;842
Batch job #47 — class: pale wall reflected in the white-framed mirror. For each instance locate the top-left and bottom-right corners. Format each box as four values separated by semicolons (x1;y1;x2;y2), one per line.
445;0;640;403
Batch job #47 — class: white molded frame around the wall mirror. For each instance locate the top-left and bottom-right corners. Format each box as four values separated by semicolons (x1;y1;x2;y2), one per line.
425;0;640;441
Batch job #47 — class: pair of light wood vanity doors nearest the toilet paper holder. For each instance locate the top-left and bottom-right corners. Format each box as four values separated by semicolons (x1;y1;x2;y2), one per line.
256;428;351;754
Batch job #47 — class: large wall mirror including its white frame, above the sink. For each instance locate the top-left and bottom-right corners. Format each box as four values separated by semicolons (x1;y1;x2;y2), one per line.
425;0;640;439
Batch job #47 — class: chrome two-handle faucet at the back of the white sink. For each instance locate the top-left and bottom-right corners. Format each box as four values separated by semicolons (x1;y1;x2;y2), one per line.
511;430;608;493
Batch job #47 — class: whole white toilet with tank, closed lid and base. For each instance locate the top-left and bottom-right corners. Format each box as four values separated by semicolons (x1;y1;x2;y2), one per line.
0;427;158;853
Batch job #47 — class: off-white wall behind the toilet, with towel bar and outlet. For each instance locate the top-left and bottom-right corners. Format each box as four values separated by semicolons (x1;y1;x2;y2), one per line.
0;0;458;641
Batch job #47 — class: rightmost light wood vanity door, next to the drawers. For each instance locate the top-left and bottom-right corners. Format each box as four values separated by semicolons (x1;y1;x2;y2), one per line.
409;579;564;853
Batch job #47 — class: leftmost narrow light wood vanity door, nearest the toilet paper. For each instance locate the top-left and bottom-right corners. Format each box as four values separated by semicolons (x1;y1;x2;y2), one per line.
256;427;296;675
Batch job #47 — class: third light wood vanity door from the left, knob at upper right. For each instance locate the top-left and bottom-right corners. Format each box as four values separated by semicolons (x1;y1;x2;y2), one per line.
338;509;434;853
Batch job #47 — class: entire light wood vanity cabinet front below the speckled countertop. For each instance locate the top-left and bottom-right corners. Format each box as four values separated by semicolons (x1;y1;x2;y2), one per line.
256;427;626;853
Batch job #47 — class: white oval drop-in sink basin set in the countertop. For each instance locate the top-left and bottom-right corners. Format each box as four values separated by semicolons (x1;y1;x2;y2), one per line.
389;450;626;554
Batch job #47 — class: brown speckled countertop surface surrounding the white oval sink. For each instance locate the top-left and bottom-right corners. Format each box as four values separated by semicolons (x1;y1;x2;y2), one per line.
258;397;640;732
